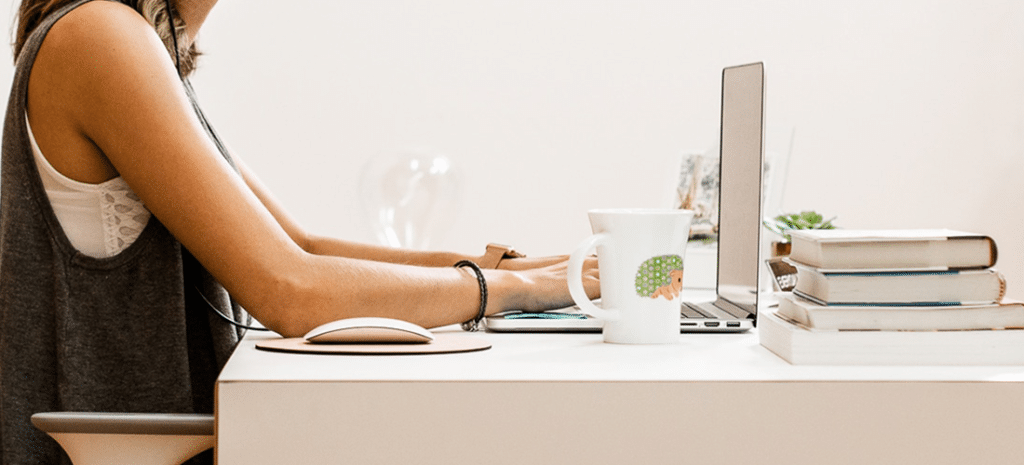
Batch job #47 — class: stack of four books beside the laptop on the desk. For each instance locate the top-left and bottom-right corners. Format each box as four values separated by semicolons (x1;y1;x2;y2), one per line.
758;229;1024;365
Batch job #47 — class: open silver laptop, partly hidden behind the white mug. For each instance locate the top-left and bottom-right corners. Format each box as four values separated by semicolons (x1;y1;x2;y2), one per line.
486;62;764;332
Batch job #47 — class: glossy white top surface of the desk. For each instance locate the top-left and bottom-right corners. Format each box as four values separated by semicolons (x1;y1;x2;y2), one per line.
219;327;1024;383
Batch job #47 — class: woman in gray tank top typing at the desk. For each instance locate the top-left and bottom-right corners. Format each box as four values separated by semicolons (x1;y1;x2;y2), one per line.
0;0;598;463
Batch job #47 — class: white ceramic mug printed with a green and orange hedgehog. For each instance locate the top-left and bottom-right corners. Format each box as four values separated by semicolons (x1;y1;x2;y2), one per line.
568;209;693;344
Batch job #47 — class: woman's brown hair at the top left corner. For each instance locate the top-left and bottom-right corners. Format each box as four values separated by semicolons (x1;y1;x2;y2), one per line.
12;0;201;77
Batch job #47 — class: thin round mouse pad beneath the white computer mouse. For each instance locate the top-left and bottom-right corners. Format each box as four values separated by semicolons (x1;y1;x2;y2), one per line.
256;333;490;355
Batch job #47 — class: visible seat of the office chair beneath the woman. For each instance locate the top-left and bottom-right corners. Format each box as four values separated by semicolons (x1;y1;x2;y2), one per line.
32;412;214;465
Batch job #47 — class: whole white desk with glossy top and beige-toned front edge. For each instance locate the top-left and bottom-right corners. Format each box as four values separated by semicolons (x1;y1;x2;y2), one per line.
216;315;1024;465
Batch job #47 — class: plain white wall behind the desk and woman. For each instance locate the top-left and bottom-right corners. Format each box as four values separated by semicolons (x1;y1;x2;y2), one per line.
4;0;1024;296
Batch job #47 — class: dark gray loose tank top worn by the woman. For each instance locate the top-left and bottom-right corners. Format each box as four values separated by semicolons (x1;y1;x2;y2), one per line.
0;0;244;464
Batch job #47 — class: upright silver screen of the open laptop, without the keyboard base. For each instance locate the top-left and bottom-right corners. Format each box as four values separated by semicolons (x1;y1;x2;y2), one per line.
718;62;764;313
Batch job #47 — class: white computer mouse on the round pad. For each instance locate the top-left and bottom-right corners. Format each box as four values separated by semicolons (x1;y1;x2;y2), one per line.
304;316;434;344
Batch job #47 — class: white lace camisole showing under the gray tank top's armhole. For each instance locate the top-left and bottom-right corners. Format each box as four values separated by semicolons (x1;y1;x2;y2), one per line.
25;115;151;258
